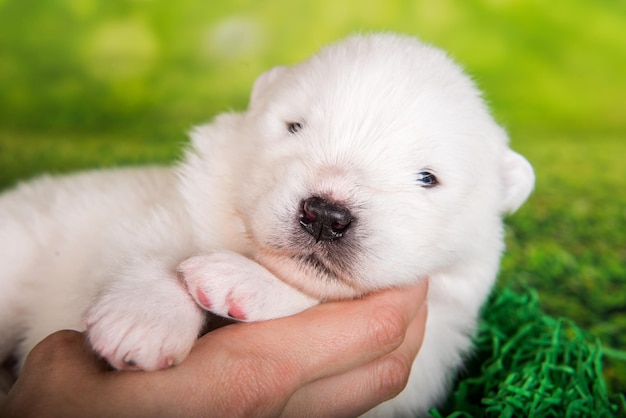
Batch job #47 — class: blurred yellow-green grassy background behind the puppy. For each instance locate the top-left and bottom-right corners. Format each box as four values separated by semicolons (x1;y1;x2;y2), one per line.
0;0;626;392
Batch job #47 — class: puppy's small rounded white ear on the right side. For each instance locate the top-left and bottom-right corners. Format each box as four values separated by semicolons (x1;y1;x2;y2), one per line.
502;149;535;213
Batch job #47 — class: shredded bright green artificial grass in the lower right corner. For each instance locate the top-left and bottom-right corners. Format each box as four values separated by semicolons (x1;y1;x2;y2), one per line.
431;288;626;418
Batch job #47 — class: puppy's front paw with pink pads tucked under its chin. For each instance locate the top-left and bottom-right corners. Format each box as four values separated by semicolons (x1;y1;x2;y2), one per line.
178;251;319;322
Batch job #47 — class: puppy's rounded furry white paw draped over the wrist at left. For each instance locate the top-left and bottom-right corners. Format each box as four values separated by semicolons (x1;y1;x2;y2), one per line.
85;260;205;370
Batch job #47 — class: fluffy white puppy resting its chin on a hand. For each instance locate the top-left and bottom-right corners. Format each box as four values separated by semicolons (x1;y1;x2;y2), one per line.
0;34;534;416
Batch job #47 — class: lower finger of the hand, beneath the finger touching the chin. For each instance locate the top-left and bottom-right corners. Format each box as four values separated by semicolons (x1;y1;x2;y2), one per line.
283;305;427;417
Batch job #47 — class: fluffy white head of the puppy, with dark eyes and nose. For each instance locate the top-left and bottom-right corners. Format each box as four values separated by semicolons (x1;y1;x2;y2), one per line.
238;35;534;299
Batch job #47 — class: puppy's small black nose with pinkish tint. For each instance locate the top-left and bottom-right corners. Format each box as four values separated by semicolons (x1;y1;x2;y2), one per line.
300;196;352;241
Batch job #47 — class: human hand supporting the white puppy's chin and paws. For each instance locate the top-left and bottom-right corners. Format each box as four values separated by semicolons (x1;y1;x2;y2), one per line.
0;282;427;417
